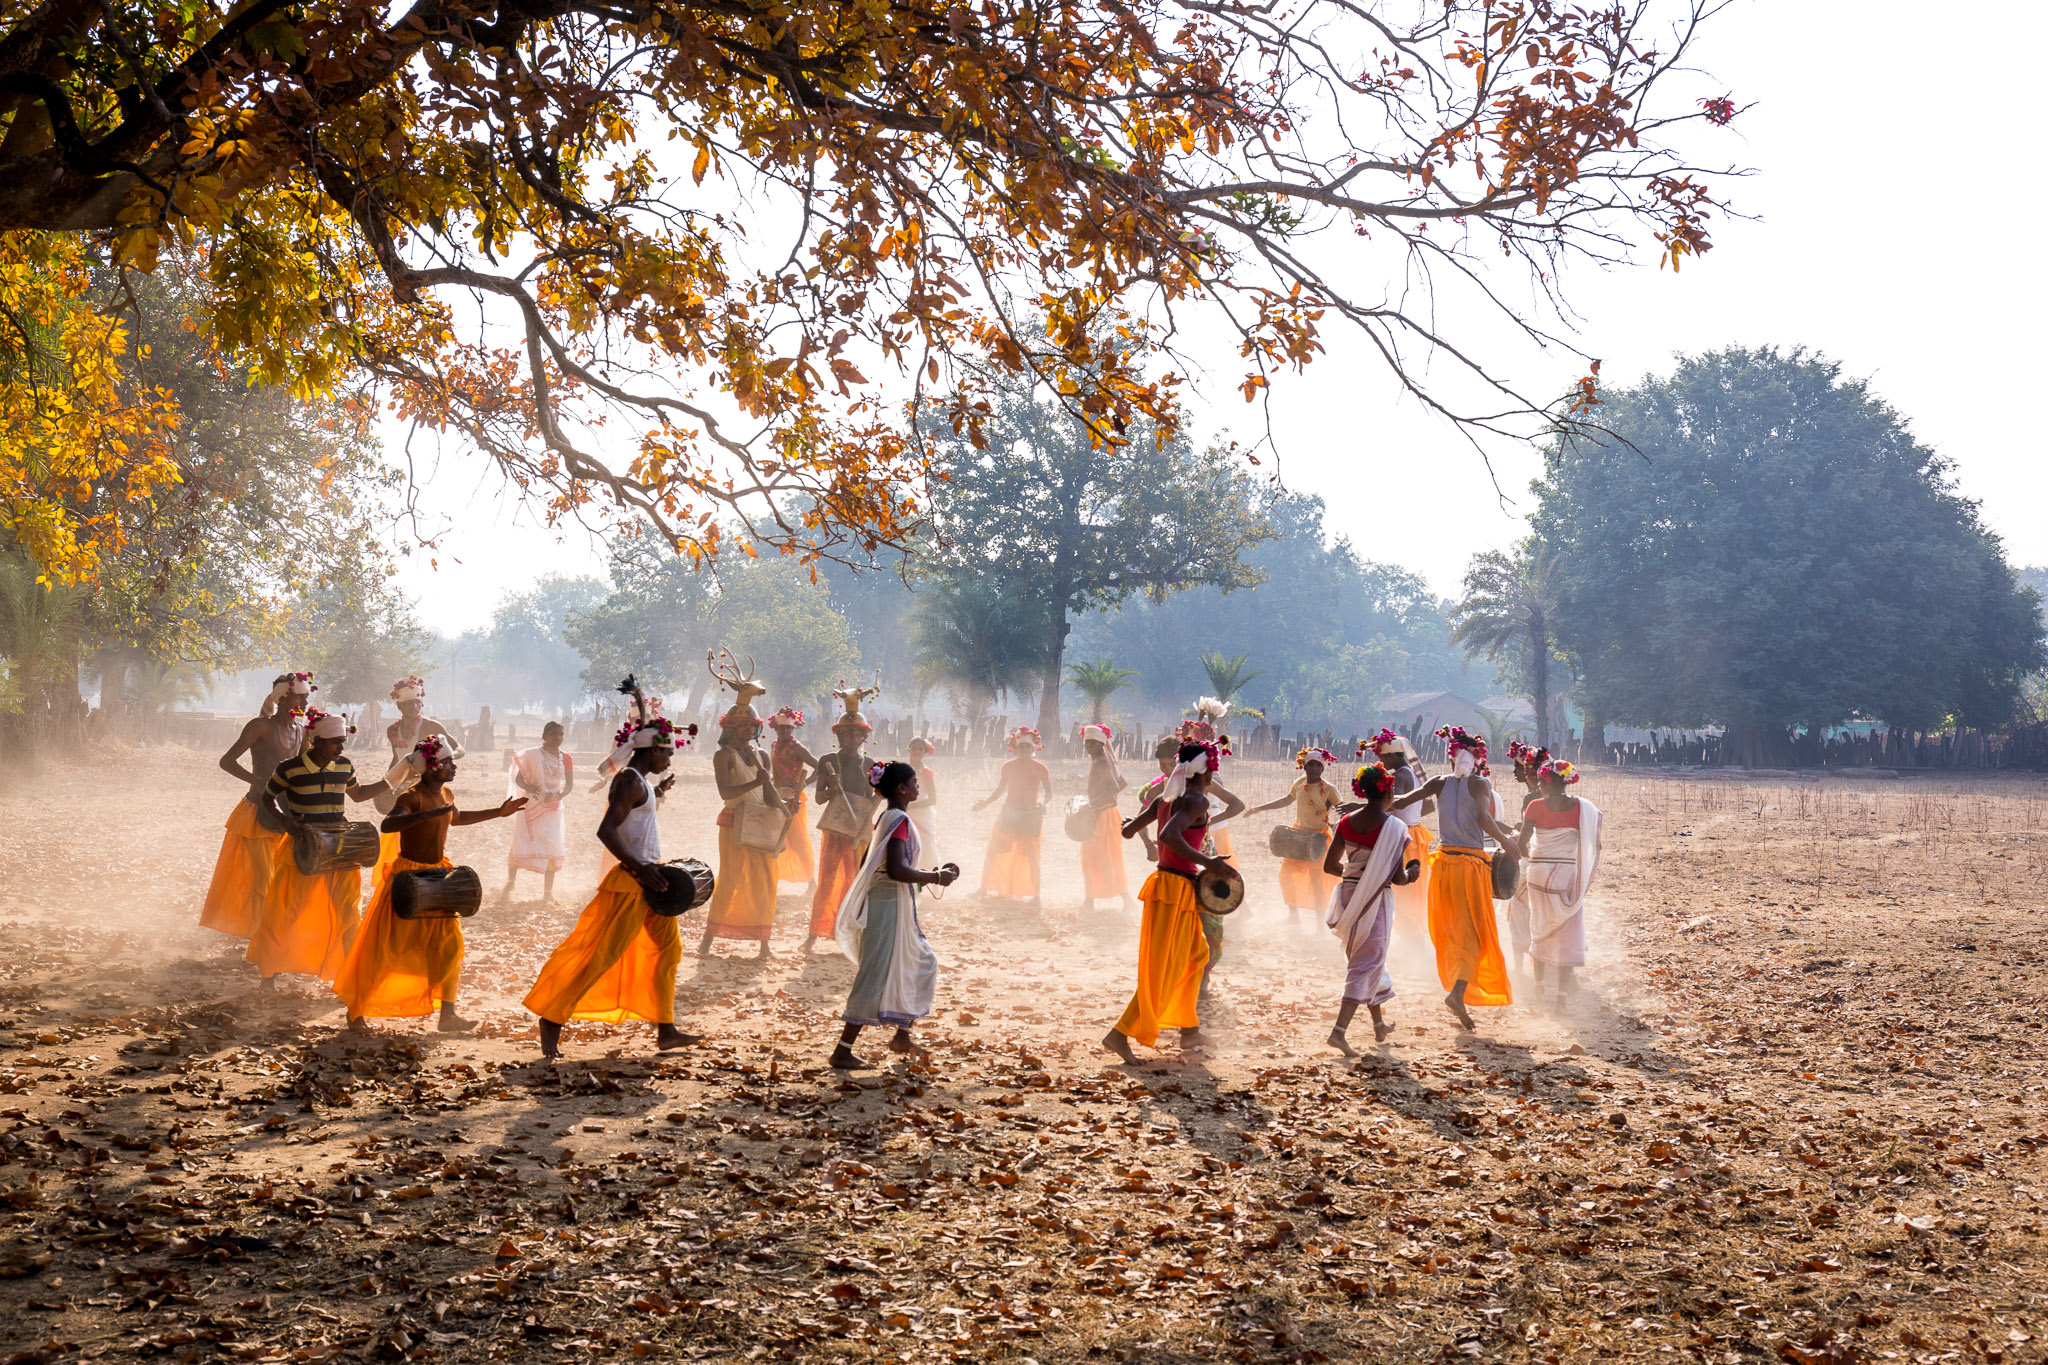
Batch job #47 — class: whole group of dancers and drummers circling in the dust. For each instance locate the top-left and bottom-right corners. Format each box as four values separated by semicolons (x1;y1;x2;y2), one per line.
201;657;1599;1068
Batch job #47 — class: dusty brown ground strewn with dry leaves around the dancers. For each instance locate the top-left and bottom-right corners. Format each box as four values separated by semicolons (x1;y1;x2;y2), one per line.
0;751;2048;1365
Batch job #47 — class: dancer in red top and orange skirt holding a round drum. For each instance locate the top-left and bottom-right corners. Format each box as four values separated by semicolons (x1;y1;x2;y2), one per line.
1102;741;1237;1062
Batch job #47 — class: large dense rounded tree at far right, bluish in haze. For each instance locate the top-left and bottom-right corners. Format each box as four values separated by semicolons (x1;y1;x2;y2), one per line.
1534;348;2044;761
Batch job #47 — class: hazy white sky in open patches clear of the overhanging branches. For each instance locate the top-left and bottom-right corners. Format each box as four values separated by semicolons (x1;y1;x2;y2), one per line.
401;0;2048;634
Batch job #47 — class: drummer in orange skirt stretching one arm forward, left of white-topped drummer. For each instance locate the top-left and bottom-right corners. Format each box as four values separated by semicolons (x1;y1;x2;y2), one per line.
334;735;526;1033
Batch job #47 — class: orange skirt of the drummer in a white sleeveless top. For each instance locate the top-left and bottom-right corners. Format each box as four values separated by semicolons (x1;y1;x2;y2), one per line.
526;868;682;1023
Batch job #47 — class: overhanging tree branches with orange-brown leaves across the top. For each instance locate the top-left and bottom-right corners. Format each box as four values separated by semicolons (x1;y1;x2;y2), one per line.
0;0;1733;557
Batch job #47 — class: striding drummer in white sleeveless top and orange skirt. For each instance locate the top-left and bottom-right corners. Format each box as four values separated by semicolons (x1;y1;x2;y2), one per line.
526;716;702;1058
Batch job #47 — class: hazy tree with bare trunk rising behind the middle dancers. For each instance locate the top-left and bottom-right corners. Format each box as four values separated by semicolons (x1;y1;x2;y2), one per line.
922;368;1272;735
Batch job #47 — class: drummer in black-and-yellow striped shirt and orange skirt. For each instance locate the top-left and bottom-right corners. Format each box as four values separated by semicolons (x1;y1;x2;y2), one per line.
248;710;391;988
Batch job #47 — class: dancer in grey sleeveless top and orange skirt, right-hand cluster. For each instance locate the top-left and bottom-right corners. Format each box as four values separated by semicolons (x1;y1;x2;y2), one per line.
1397;726;1516;1029
